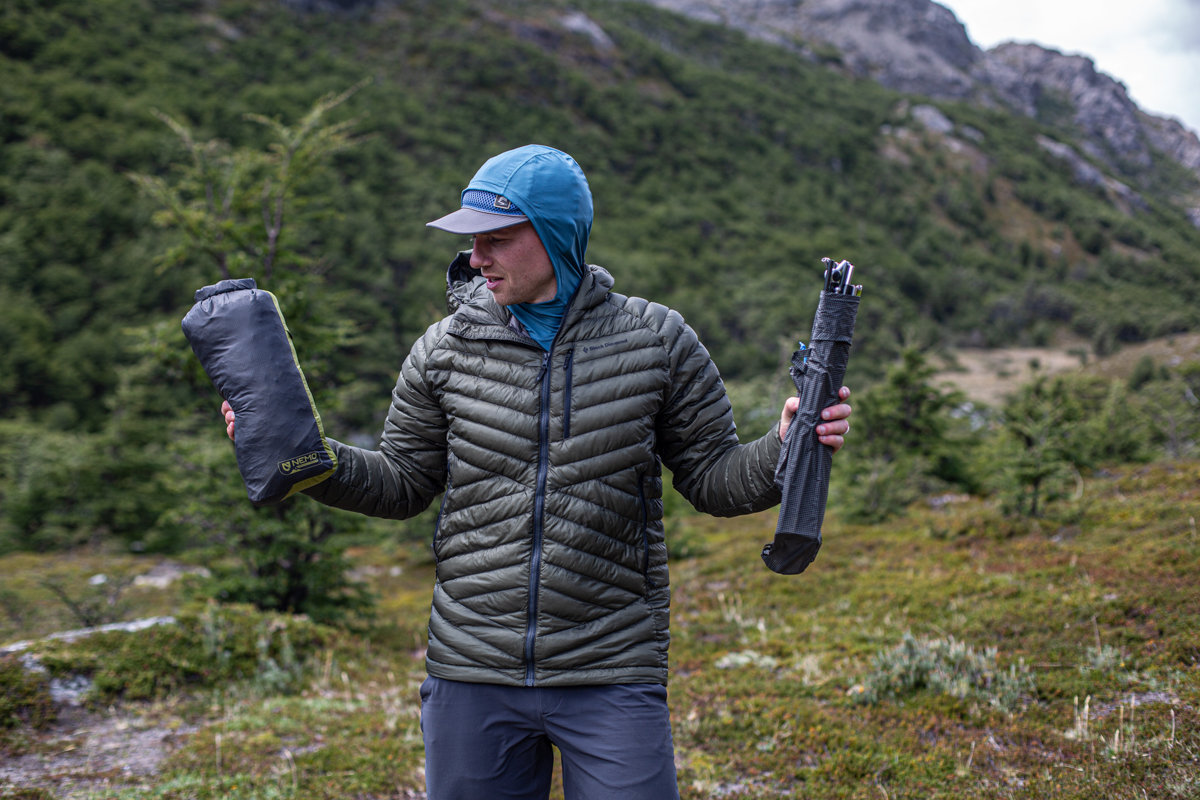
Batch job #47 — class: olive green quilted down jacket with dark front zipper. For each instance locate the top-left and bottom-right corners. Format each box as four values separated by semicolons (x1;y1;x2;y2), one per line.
306;257;780;686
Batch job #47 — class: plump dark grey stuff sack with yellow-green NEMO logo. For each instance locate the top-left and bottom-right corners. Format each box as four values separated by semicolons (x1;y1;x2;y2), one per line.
184;278;337;505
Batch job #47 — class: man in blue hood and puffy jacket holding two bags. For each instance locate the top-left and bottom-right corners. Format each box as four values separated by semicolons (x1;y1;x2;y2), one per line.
224;145;850;800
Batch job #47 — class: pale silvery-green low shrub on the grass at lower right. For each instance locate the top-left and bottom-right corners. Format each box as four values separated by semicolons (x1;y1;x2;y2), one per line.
851;633;1034;711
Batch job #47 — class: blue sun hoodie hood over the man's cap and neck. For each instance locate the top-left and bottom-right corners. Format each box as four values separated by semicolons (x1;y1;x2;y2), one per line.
463;144;592;350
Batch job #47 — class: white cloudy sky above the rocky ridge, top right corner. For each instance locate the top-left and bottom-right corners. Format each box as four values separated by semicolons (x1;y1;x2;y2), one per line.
938;0;1200;131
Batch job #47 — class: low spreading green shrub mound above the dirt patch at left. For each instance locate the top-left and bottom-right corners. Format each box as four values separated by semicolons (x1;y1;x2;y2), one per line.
40;603;336;702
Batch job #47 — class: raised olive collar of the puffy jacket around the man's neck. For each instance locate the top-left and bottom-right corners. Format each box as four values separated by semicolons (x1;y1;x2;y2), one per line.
446;249;613;344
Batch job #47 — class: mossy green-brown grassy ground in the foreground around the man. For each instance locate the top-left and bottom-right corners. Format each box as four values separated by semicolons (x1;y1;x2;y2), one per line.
0;462;1200;800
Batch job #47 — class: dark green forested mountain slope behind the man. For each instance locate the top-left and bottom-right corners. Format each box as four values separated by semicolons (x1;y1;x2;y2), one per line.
0;0;1200;551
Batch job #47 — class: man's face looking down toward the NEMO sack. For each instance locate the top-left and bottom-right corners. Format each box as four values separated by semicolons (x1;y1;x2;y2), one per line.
470;222;558;306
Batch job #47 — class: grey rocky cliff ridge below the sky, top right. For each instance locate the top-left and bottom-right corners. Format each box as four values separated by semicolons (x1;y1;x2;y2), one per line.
624;0;1200;215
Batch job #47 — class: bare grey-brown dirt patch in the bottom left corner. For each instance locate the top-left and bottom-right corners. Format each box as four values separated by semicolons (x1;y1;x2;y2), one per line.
0;705;198;798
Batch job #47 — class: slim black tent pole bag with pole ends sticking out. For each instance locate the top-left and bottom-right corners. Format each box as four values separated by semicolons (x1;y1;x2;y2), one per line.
762;261;862;575
